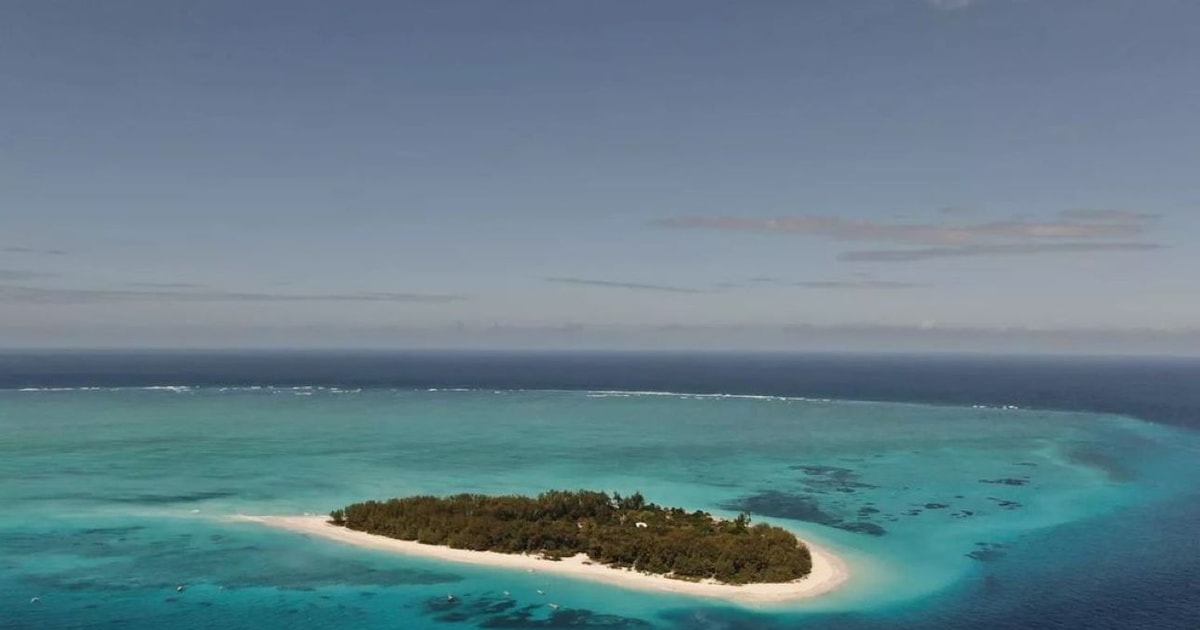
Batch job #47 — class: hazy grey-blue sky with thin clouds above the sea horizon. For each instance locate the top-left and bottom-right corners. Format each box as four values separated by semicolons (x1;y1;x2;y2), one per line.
0;0;1200;354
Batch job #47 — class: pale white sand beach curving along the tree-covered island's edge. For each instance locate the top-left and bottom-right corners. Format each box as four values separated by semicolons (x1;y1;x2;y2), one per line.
233;515;850;604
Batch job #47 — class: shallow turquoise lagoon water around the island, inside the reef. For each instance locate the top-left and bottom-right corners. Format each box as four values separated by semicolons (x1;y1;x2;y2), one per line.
0;388;1200;628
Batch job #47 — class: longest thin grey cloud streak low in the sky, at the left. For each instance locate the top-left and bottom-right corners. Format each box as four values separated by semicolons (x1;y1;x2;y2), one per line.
0;284;466;304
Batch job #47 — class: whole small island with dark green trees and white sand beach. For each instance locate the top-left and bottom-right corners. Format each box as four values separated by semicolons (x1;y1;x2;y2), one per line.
242;490;847;604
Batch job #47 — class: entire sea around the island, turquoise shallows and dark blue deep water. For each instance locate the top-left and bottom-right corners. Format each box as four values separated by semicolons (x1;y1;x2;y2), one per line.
0;352;1200;630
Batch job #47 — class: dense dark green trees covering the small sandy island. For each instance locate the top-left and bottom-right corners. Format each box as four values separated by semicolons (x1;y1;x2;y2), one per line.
330;490;812;584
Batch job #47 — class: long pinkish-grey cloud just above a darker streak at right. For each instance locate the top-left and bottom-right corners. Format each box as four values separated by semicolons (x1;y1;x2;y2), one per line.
655;216;1145;245
